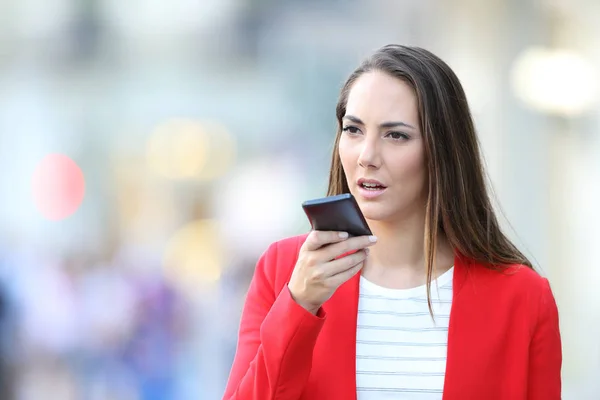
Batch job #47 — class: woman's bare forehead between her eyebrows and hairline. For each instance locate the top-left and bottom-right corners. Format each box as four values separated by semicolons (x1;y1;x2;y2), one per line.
346;71;418;126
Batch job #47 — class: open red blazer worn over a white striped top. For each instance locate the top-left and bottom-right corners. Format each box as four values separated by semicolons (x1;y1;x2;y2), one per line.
223;235;562;400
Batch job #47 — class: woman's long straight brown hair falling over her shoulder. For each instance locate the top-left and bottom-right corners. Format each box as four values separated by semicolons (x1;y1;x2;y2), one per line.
327;45;532;315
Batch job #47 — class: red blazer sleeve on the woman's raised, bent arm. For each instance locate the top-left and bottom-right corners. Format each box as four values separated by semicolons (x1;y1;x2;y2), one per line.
223;239;325;400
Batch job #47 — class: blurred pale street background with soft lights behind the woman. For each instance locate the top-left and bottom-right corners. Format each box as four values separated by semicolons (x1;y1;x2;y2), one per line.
0;0;600;400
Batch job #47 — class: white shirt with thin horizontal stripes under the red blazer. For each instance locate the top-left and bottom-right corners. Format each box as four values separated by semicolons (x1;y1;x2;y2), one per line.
356;268;454;400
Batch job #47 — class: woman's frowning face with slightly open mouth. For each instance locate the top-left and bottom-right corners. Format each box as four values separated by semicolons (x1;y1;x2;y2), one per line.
338;71;427;221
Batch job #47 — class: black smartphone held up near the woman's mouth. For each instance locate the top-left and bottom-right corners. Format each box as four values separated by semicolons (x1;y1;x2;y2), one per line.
302;193;372;236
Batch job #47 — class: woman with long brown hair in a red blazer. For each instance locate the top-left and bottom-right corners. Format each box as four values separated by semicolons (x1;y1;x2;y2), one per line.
224;45;562;400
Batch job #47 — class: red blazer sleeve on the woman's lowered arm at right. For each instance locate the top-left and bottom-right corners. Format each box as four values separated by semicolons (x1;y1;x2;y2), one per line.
527;278;562;400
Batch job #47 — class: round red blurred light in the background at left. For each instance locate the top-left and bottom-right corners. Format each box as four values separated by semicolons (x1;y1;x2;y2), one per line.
32;154;85;221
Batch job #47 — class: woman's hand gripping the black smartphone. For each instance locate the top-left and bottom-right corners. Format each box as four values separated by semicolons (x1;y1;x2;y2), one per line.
288;231;377;314
